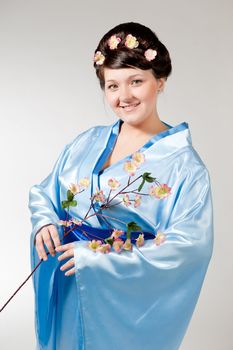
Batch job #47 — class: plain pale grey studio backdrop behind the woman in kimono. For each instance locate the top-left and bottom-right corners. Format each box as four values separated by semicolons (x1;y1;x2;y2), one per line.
0;0;233;350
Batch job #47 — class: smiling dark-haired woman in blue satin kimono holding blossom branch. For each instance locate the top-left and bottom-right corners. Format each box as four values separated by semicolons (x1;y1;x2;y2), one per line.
29;22;213;350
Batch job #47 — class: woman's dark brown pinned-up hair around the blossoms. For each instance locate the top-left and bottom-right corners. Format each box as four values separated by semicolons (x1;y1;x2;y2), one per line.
94;22;172;89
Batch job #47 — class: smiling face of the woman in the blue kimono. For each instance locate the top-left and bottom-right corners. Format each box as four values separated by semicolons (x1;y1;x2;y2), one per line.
104;68;165;125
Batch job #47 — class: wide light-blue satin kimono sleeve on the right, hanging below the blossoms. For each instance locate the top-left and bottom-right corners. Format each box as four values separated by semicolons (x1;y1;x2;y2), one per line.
74;165;213;350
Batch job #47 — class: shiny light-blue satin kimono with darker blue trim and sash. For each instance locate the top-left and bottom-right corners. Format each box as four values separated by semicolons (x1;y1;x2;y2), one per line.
29;119;213;350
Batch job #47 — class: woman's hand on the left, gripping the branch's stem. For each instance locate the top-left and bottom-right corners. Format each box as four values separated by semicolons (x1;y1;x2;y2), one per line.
35;224;61;260
